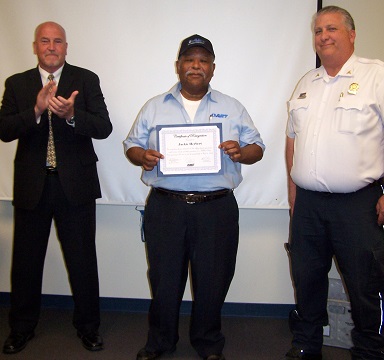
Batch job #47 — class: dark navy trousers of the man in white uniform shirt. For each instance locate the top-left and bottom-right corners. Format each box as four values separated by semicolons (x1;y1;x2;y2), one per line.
290;185;384;360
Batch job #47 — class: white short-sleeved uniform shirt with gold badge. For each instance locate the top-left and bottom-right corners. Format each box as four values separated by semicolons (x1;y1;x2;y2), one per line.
286;55;384;193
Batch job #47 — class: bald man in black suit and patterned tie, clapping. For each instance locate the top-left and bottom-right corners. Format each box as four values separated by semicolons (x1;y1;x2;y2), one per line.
0;22;112;354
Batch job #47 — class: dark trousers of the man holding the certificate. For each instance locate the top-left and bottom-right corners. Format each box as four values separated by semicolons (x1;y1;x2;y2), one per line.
144;191;239;357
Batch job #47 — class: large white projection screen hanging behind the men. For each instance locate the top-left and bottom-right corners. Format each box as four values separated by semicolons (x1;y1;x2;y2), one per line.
0;0;317;209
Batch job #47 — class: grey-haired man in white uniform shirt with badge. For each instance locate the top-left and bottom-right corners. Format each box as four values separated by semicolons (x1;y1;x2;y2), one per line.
285;6;384;360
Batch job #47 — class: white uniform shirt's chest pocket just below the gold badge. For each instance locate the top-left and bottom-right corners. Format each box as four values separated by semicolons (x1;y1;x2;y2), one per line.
334;96;364;134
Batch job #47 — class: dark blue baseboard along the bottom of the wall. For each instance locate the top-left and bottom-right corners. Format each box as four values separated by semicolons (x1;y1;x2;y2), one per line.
0;292;295;319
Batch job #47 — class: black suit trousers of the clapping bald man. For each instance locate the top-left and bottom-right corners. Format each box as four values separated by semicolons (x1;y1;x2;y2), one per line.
9;175;100;333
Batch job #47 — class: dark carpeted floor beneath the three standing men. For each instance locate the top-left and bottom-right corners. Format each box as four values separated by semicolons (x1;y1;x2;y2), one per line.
0;307;350;360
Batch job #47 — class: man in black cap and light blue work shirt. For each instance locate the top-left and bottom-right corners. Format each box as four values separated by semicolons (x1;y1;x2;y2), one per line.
124;35;265;360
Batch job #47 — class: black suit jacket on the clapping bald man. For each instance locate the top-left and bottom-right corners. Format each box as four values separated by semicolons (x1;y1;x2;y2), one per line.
0;63;112;209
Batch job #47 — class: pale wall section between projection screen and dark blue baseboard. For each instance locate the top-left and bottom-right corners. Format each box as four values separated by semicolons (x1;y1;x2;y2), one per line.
0;201;293;304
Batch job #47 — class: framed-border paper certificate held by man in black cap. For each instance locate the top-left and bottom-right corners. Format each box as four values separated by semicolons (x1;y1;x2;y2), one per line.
156;123;222;176
